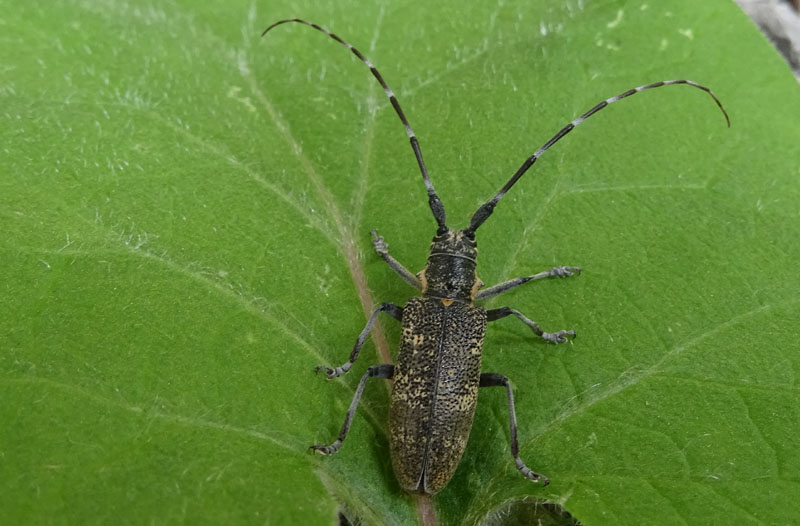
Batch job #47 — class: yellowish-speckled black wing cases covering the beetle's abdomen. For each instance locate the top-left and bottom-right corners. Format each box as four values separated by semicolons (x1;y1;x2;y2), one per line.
389;297;486;494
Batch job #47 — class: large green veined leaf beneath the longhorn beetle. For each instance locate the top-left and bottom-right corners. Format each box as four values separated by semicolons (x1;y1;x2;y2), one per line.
0;0;800;525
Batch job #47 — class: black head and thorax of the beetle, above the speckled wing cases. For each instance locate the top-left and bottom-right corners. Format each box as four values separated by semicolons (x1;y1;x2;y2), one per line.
418;228;480;301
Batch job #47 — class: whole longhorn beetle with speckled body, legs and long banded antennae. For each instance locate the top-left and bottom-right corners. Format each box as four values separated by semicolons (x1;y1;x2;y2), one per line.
262;18;730;495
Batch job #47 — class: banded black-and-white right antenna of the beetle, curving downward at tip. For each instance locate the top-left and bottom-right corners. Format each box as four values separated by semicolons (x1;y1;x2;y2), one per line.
466;80;731;234
